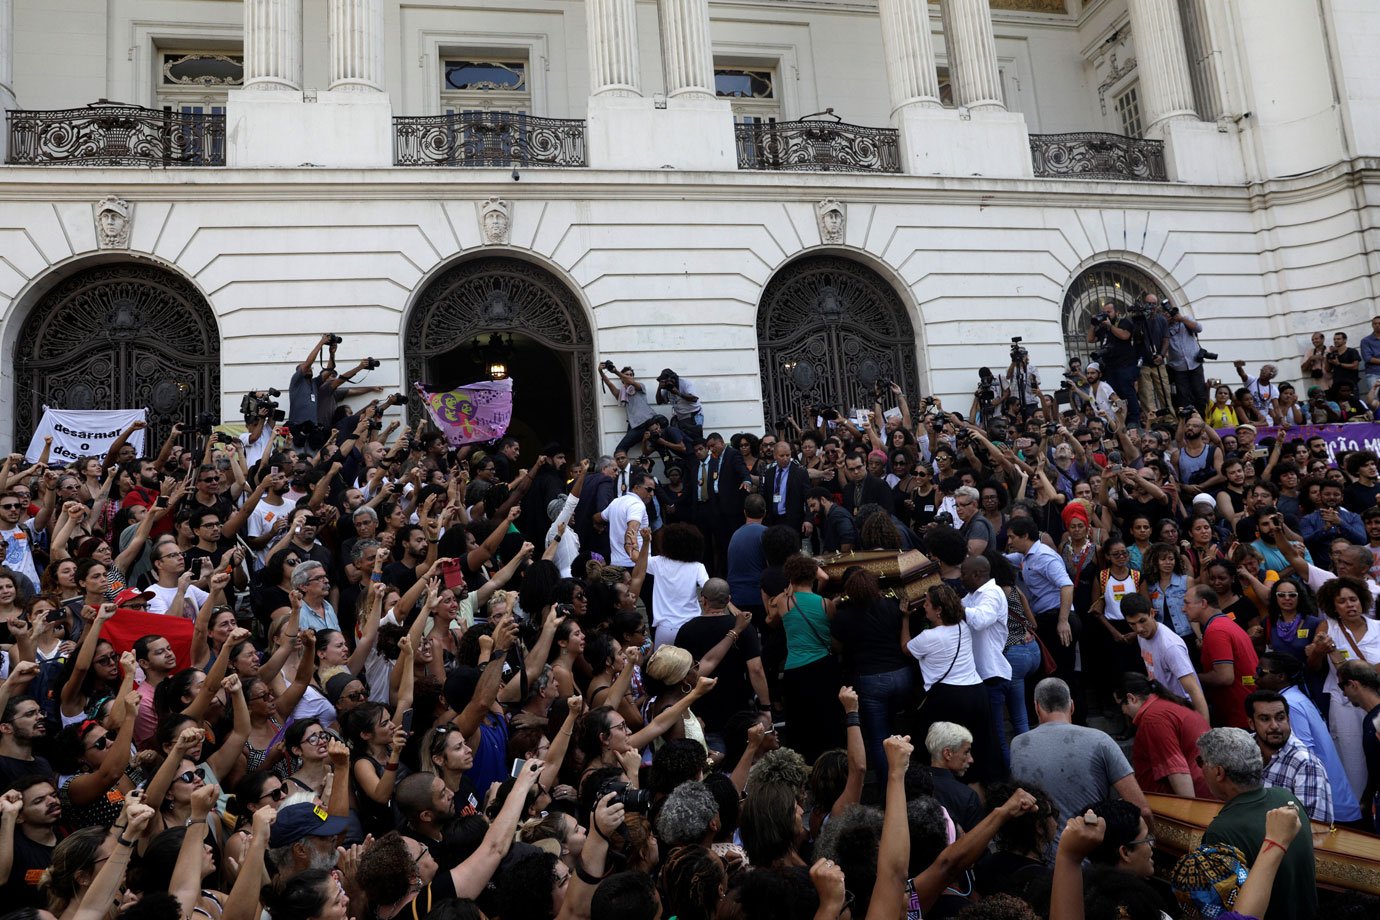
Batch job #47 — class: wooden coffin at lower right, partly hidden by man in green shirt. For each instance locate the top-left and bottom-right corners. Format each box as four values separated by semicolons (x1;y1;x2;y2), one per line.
1145;793;1380;895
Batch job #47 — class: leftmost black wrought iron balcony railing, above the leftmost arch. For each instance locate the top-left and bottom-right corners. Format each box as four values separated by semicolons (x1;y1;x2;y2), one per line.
6;99;225;167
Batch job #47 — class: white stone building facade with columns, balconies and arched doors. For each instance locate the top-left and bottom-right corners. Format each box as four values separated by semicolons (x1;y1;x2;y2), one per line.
0;0;1380;450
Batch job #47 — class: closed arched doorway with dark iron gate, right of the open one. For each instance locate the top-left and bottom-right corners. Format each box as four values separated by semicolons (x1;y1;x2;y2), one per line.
758;255;919;430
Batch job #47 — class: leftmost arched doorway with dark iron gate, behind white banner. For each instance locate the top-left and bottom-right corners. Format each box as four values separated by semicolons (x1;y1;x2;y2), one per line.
14;262;221;444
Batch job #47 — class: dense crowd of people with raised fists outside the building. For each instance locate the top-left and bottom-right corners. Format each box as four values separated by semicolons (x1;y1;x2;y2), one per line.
0;320;1380;920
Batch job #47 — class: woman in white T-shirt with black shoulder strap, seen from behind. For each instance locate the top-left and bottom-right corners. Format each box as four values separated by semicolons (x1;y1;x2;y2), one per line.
901;585;1005;783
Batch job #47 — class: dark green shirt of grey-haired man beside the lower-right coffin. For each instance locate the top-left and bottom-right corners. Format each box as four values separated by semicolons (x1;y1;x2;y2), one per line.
1203;786;1318;920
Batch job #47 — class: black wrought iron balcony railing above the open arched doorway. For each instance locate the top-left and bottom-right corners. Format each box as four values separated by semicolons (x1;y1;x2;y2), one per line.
393;112;587;167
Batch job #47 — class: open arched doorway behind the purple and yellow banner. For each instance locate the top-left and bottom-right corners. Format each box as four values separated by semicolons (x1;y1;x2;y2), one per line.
406;257;599;458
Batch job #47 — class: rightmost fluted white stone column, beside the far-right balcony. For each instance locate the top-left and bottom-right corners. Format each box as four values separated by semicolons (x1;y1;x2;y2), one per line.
1129;0;1198;138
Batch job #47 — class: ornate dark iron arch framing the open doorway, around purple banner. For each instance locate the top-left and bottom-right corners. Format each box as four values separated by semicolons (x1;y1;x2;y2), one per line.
406;257;599;457
